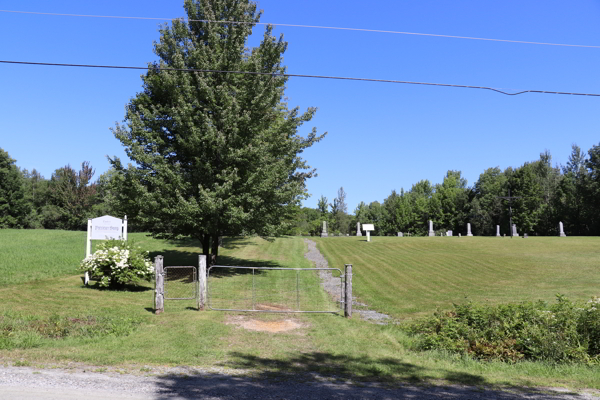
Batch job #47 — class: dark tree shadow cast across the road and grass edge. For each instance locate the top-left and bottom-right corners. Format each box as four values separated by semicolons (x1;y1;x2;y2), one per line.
150;352;576;400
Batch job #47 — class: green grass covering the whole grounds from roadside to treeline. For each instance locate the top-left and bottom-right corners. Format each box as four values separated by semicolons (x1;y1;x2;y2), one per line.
0;230;600;388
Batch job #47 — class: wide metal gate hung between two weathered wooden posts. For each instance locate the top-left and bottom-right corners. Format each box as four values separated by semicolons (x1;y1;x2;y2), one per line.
207;265;345;313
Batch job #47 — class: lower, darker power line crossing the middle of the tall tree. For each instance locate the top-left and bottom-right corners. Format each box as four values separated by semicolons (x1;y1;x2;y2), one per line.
0;60;600;97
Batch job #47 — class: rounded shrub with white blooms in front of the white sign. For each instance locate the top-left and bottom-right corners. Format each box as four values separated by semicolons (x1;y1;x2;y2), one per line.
79;240;154;287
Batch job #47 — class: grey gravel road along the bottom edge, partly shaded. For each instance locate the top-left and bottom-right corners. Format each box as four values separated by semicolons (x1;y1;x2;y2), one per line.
0;367;600;400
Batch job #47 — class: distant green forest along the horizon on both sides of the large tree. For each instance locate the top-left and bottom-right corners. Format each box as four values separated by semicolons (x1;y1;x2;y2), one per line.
0;144;600;236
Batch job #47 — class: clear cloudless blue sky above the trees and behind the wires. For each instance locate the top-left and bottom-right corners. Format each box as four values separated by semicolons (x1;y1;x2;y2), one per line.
0;0;600;212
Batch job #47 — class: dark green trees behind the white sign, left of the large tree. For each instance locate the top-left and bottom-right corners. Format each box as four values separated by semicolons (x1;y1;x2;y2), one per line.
0;148;120;230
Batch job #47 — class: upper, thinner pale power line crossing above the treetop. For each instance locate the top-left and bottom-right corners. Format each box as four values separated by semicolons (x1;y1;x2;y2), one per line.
0;10;600;49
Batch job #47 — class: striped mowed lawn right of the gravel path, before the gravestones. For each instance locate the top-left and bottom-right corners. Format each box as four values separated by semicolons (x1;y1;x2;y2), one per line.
314;237;600;319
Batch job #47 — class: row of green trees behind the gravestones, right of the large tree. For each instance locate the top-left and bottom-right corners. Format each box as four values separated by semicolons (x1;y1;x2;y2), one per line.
293;144;600;236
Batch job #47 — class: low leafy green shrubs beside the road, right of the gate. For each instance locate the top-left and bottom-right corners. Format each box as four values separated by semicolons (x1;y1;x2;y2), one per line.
407;295;600;363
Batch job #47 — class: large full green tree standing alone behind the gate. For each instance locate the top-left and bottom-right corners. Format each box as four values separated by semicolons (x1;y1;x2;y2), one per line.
113;0;324;262
